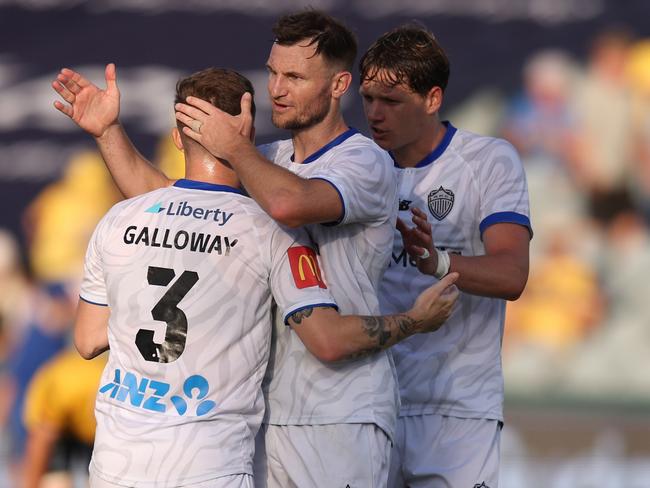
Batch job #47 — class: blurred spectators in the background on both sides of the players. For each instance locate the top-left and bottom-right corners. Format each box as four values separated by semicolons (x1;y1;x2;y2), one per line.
0;25;650;487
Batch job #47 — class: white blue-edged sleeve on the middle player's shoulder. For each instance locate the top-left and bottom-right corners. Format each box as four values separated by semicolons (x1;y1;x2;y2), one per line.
310;141;397;224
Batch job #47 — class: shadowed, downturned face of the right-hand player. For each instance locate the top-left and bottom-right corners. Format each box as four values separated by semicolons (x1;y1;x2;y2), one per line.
359;74;430;152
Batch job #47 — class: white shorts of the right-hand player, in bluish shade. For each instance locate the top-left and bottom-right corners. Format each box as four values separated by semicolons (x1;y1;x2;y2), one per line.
388;415;502;488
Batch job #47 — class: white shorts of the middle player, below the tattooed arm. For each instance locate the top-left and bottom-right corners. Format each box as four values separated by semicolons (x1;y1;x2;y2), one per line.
254;424;391;488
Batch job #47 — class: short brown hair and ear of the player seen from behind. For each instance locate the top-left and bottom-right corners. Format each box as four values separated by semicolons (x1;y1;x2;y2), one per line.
174;68;255;151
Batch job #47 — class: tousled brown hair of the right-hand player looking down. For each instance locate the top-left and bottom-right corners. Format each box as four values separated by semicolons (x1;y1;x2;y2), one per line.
359;24;449;95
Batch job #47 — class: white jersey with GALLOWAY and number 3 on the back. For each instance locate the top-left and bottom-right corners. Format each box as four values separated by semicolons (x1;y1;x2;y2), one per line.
81;180;333;487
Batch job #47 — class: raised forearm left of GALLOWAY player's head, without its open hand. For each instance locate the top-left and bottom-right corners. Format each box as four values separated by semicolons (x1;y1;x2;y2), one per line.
95;124;171;198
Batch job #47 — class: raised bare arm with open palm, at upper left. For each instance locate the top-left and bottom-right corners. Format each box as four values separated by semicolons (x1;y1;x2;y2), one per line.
52;63;172;198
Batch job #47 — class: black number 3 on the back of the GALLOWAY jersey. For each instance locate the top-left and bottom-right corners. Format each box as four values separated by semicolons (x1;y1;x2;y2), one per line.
135;266;199;363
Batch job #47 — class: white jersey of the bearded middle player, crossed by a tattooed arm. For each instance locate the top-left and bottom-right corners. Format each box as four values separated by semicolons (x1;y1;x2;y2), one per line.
261;129;399;437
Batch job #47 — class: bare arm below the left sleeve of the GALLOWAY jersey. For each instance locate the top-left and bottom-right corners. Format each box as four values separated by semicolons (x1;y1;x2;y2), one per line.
74;299;111;359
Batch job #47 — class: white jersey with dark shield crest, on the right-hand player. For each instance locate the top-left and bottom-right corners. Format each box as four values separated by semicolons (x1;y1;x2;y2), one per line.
380;124;530;420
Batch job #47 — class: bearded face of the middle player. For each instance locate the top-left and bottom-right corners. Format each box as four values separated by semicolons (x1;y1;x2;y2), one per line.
266;41;335;131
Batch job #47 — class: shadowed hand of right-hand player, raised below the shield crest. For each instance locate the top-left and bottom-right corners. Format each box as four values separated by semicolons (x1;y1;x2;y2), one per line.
397;207;438;276
